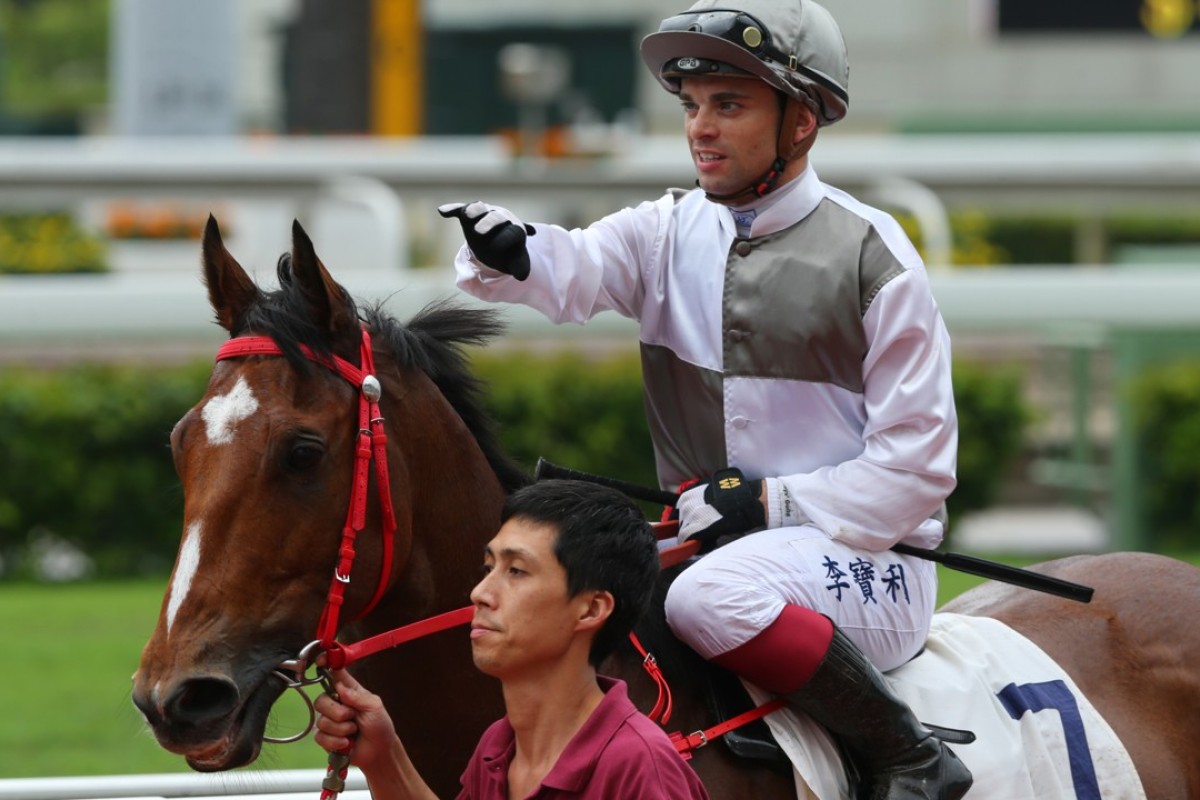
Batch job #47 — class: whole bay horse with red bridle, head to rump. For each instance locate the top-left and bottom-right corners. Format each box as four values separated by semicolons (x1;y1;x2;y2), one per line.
132;217;1200;800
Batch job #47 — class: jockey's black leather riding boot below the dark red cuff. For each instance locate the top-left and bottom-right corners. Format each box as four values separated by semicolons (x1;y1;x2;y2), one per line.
786;627;971;800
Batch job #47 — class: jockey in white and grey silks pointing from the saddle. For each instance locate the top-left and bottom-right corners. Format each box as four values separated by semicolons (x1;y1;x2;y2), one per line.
439;0;971;800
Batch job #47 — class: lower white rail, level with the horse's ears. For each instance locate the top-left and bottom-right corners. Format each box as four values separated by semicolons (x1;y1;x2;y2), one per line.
7;266;1200;348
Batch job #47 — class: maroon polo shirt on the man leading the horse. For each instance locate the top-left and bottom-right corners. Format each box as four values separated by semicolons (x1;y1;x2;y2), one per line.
458;676;708;800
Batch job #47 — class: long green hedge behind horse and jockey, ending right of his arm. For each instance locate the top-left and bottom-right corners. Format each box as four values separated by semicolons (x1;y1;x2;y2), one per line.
0;350;1027;577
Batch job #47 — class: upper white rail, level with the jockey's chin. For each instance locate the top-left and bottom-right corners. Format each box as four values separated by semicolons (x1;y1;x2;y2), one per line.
7;131;1200;210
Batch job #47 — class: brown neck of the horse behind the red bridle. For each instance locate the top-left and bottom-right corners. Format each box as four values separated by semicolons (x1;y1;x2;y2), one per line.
352;367;505;796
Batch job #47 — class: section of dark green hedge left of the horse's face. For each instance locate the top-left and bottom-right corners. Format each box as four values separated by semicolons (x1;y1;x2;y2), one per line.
0;365;211;576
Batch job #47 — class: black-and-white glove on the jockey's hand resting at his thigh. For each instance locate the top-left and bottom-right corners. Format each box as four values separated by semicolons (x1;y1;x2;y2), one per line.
676;467;767;553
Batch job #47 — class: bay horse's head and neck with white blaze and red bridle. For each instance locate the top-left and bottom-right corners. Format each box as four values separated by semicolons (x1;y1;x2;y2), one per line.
133;217;527;780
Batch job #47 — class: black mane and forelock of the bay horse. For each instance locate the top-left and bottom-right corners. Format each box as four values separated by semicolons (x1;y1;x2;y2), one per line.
232;254;532;493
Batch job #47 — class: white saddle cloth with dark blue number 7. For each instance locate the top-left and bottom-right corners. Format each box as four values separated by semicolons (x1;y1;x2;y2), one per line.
746;614;1146;800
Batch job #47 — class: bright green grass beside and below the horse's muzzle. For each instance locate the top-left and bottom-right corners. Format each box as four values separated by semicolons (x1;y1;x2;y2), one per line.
0;581;325;778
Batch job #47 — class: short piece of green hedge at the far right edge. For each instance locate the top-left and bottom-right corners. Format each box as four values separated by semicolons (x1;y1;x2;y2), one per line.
1129;360;1200;548
